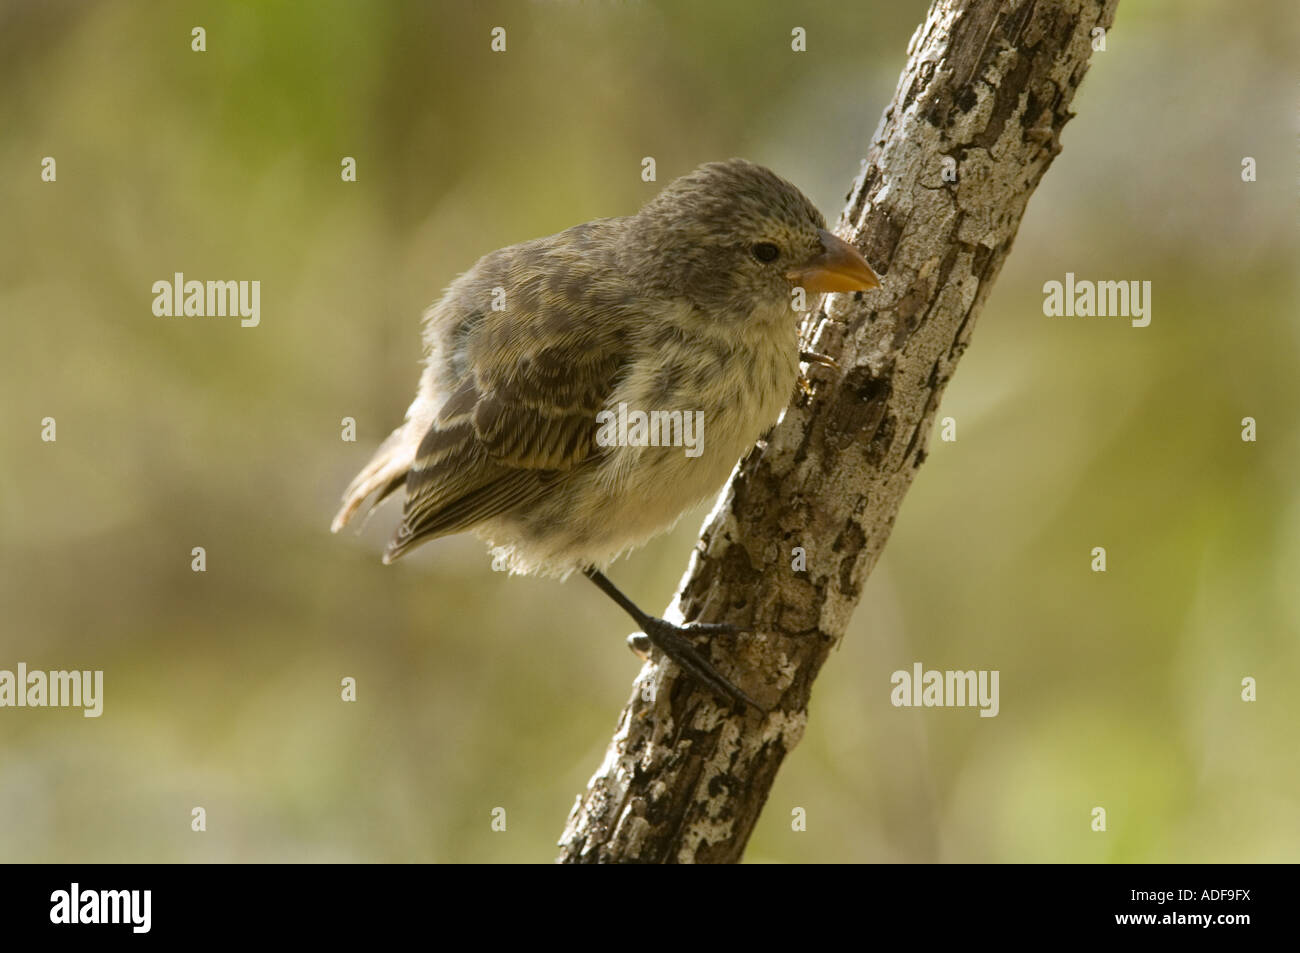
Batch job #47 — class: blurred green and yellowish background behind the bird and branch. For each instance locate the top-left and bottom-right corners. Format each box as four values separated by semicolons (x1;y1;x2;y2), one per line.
0;0;1300;862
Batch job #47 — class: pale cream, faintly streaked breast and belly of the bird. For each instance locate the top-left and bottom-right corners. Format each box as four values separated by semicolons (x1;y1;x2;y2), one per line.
486;302;798;572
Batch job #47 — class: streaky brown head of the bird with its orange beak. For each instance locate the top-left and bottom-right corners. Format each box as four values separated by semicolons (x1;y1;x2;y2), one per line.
625;159;880;319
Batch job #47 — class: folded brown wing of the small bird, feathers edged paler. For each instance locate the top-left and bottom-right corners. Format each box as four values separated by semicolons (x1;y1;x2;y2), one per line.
385;234;629;560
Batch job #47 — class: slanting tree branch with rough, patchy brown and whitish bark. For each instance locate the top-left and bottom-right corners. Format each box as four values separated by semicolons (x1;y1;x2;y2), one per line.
559;0;1118;863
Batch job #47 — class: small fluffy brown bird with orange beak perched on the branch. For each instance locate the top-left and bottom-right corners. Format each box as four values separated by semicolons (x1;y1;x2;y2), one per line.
332;159;880;709
